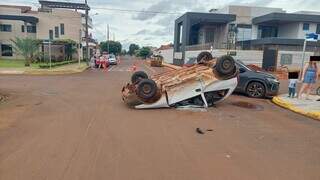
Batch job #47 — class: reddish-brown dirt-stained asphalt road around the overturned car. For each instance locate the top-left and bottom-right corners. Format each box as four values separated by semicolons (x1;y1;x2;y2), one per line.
0;58;320;180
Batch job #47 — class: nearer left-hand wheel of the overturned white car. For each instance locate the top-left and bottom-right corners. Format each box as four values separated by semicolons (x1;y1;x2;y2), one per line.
136;79;158;101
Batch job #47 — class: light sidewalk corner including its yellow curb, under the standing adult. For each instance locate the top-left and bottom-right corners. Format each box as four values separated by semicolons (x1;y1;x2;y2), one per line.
272;94;320;120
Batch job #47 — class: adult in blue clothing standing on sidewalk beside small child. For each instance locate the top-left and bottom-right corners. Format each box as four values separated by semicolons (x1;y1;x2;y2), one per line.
298;61;319;99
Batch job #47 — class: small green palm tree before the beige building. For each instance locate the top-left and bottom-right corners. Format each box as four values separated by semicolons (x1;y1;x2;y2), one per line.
11;37;39;66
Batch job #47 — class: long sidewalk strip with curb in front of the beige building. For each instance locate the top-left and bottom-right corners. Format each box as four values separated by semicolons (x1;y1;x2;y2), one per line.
0;63;88;75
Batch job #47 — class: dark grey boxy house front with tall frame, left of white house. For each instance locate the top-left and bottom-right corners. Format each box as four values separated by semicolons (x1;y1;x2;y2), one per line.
174;12;236;64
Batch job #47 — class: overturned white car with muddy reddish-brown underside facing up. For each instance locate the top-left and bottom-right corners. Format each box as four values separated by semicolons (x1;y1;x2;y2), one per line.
122;52;238;109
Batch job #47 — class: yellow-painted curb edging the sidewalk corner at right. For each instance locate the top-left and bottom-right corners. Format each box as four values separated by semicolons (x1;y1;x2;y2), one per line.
272;96;320;120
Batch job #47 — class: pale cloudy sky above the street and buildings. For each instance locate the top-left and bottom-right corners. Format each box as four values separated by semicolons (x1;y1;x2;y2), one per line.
0;0;320;47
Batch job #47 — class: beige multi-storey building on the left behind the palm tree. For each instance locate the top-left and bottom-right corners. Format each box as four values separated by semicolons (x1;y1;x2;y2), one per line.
0;5;96;59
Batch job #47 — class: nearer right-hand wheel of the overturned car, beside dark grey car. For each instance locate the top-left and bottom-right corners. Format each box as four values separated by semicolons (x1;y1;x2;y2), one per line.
214;55;236;77
